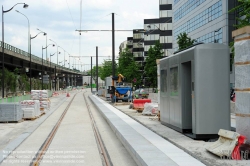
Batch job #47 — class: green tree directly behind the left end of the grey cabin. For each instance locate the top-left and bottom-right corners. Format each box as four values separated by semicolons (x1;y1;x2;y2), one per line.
144;40;163;87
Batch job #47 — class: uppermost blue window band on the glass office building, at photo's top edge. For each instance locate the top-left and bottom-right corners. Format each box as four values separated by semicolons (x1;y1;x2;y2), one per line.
174;0;206;21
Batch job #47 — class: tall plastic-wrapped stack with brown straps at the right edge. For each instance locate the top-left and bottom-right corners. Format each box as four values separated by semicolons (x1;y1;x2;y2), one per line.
232;26;250;143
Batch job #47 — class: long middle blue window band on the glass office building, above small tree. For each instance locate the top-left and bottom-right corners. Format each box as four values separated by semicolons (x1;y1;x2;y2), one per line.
174;0;222;38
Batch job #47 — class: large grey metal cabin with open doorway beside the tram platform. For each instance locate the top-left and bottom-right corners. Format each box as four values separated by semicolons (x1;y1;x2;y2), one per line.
160;43;231;139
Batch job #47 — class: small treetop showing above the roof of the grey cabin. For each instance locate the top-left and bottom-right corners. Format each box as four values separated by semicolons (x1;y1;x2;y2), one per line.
177;32;196;50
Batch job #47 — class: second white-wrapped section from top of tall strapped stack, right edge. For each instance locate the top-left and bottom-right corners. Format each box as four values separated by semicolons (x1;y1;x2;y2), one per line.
235;65;250;89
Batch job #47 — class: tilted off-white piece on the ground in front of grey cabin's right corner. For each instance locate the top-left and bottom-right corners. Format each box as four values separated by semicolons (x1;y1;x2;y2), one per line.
206;129;240;157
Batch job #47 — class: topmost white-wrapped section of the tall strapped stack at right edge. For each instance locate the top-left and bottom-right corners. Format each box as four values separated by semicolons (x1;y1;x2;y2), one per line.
234;40;250;63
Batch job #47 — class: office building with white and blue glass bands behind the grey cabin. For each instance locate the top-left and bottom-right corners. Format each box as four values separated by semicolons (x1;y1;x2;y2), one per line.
173;0;235;51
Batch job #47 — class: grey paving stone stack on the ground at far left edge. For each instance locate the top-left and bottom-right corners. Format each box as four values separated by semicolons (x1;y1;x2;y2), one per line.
0;103;23;122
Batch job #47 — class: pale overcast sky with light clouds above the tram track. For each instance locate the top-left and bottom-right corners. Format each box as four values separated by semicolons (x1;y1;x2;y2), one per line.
0;0;159;70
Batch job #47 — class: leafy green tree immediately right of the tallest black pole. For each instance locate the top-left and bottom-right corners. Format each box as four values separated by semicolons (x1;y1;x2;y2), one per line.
118;48;140;84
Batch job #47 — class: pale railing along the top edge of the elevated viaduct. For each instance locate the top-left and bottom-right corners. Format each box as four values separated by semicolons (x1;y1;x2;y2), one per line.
0;41;80;73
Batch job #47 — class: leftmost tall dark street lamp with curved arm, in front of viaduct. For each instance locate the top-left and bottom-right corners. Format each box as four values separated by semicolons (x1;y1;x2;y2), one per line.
1;3;29;98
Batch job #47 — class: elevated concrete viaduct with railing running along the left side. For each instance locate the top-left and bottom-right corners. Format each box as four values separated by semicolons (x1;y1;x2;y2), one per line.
0;42;85;89
